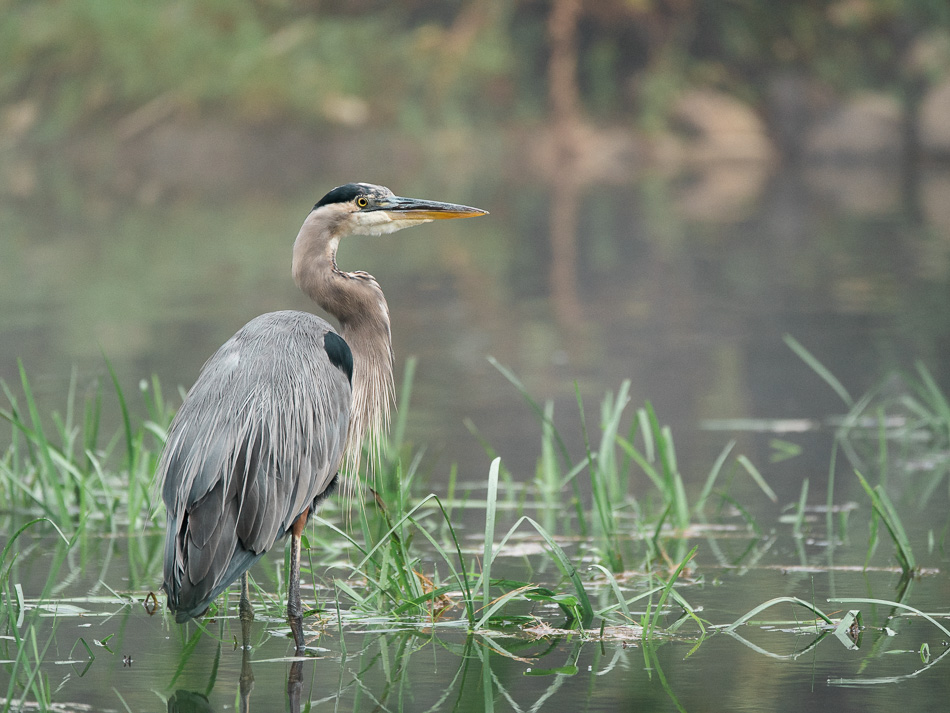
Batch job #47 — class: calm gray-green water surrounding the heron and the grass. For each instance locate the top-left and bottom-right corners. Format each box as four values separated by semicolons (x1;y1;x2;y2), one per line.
0;136;950;711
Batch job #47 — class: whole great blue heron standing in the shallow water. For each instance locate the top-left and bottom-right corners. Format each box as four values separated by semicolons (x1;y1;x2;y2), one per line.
158;183;485;650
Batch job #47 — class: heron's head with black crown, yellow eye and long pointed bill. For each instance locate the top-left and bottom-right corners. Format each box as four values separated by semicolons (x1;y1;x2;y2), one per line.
311;183;488;236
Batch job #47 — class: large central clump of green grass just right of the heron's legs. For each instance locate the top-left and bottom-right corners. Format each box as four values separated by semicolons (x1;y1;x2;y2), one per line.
292;362;767;637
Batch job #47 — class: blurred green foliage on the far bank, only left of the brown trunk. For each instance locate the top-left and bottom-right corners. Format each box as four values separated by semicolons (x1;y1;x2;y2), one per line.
0;0;510;136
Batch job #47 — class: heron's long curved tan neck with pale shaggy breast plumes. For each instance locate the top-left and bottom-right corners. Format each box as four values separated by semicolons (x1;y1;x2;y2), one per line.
293;213;394;475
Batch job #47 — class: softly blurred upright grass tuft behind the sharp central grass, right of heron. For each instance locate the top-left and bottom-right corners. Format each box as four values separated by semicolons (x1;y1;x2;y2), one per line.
486;359;776;573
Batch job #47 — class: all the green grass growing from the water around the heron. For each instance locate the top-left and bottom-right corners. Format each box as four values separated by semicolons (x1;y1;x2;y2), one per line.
0;348;946;710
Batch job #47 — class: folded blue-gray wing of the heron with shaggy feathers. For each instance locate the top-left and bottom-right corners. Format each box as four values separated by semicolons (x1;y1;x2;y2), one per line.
158;311;352;621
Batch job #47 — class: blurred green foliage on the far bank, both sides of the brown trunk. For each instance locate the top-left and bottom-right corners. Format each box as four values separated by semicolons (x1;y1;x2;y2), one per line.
0;0;950;138
